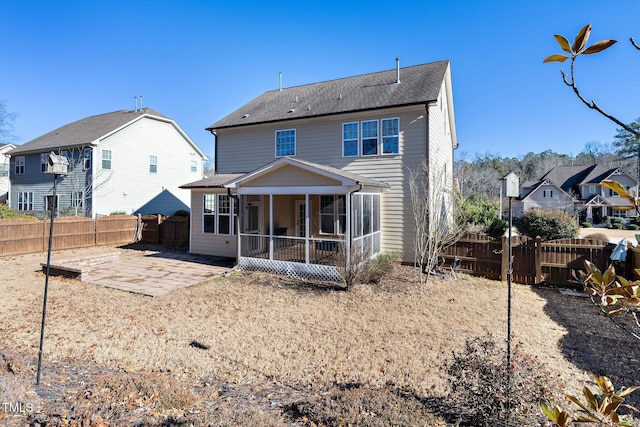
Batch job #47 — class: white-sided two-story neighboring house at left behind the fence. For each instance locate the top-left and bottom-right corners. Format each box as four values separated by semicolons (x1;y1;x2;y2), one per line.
8;108;206;217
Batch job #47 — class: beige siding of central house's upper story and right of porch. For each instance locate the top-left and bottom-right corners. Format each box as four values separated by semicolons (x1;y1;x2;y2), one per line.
218;105;436;262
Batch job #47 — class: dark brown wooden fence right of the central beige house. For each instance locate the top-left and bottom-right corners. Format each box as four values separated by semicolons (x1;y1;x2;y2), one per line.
444;234;616;285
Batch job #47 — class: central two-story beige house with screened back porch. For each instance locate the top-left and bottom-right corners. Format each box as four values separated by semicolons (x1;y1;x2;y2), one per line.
184;61;457;278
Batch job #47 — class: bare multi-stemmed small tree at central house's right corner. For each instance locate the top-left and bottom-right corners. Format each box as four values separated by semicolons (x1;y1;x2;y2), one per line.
409;160;464;283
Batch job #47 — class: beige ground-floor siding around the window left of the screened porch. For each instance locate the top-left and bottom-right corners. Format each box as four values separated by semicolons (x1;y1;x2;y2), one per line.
189;189;237;258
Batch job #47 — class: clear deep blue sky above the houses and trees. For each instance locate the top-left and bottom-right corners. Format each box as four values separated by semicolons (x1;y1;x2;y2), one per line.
0;0;640;159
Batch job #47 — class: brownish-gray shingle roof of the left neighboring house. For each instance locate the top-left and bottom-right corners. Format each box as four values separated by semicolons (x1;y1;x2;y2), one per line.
8;108;170;156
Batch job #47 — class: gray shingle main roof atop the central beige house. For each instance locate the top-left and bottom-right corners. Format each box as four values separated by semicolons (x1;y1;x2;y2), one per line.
207;61;449;130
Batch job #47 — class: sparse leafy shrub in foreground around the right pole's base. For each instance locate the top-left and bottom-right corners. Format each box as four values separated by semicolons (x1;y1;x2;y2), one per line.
445;334;561;426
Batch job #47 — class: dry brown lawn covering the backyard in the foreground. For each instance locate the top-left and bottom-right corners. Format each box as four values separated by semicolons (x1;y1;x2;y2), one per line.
0;248;640;425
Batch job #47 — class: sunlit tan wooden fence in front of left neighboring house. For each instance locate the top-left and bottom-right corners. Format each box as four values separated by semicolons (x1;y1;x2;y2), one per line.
0;215;140;256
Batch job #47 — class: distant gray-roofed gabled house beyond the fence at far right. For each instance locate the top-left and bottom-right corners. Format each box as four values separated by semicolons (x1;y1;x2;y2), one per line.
515;165;638;224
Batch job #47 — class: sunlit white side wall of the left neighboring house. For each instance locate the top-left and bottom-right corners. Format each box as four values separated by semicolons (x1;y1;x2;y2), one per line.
94;118;202;215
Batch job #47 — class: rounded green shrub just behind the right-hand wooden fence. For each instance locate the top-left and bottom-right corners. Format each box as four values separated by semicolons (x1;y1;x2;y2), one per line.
518;209;578;240
